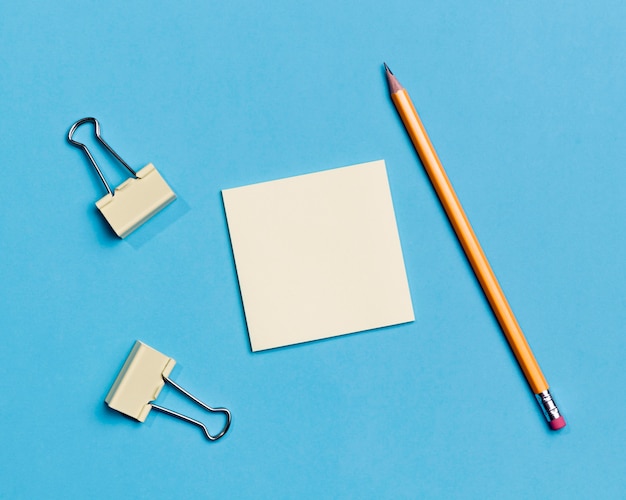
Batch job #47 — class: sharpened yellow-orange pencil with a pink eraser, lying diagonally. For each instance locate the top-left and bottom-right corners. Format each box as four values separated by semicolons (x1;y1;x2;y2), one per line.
385;64;565;430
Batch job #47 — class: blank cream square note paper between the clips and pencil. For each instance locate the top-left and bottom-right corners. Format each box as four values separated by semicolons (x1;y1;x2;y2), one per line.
222;160;414;351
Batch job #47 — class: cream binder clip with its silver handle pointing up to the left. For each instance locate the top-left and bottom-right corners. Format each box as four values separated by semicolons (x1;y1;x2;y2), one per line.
67;118;176;238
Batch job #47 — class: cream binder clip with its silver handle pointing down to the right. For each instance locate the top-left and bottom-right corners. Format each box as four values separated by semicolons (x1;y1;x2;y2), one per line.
105;340;231;441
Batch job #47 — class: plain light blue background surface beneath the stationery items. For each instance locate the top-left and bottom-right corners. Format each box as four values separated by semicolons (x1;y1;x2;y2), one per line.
0;0;626;498
